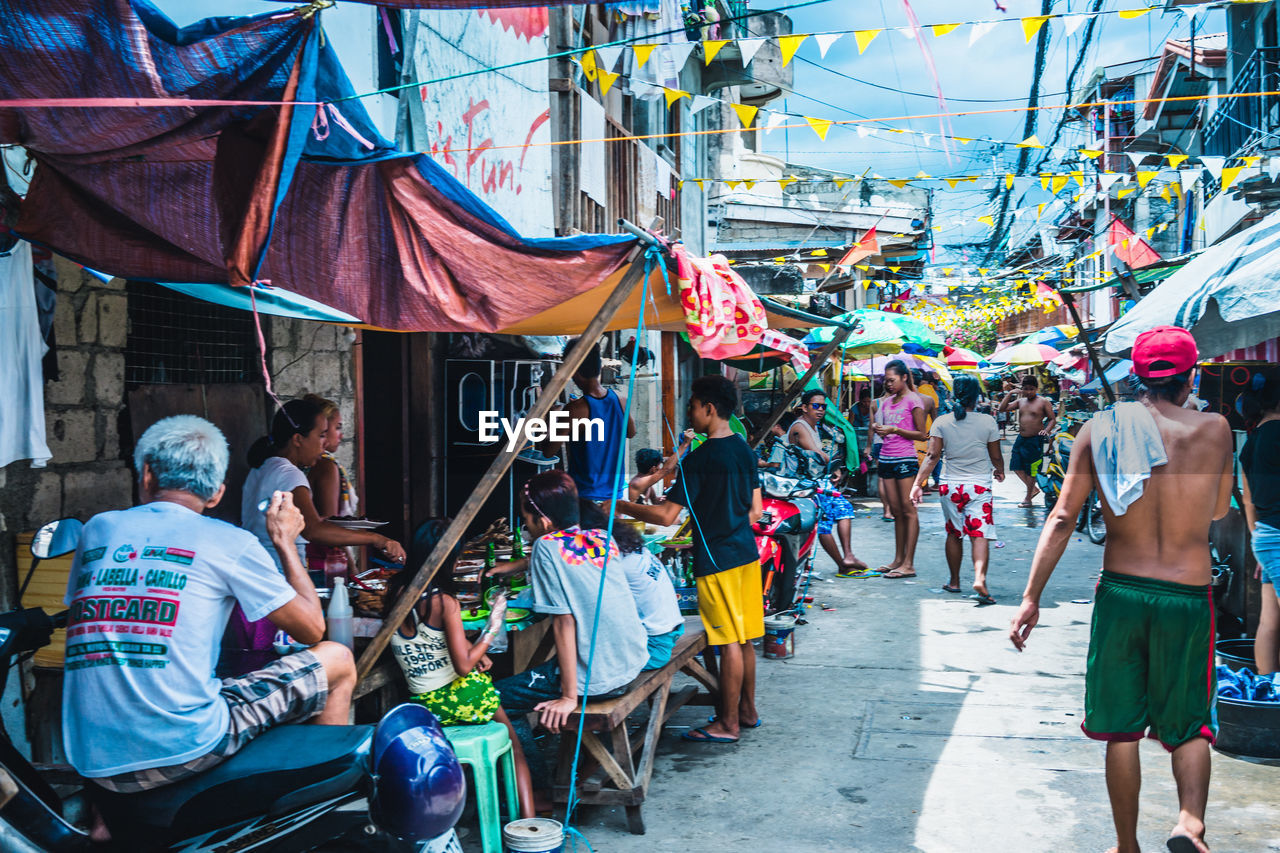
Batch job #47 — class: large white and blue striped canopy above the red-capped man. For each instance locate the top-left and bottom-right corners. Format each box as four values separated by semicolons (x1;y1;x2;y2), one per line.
1105;207;1280;359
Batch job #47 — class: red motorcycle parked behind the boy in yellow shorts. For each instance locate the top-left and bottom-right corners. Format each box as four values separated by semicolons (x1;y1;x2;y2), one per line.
751;474;833;615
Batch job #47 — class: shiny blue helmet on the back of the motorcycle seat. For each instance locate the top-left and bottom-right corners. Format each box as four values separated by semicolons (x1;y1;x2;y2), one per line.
369;703;467;841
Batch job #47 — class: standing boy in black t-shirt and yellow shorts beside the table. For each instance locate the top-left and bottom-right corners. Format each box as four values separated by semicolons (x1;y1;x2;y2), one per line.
618;375;764;743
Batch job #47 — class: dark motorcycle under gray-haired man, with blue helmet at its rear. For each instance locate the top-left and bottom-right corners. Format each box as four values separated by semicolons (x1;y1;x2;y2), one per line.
0;519;466;853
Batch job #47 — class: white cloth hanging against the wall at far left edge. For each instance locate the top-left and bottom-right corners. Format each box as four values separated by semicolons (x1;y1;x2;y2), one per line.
0;241;52;467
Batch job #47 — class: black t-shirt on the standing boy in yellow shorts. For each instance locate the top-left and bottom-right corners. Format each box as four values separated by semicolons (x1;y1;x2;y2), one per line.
667;434;760;578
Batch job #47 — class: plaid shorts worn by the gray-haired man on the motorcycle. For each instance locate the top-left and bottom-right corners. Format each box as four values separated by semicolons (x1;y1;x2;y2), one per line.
92;651;329;794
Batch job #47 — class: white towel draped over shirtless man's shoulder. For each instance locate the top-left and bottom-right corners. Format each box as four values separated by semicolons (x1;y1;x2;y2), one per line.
1089;402;1169;515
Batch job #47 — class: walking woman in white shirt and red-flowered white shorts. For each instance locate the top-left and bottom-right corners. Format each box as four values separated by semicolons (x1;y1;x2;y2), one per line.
911;377;1005;605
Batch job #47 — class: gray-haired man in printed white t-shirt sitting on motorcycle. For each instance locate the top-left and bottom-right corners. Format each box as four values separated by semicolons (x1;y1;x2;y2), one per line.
63;415;356;793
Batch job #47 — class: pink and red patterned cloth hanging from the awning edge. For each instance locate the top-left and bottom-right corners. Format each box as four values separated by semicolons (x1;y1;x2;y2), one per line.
672;243;769;359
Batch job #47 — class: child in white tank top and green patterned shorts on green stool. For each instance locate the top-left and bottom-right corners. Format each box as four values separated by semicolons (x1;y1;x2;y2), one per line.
387;519;535;817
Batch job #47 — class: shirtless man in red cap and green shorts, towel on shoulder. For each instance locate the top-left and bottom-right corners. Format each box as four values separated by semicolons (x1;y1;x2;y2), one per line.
1009;325;1231;853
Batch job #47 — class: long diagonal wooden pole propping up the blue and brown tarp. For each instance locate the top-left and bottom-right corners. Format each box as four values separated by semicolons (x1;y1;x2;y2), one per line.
356;233;660;679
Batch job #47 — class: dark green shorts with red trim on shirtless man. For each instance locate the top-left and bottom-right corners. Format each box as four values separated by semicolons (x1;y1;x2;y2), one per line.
1080;571;1217;751
